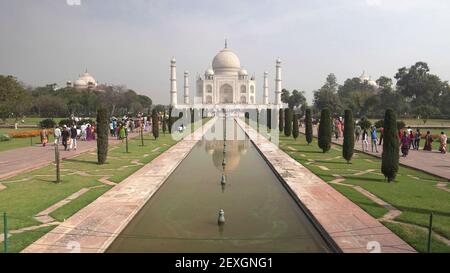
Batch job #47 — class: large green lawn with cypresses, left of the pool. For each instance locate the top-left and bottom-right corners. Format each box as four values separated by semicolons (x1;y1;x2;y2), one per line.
0;120;210;252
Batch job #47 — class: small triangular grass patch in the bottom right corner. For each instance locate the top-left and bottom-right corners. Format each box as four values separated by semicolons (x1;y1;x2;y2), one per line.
383;222;450;253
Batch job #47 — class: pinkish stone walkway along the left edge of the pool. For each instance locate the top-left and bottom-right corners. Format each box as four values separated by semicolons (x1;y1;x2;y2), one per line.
23;118;216;253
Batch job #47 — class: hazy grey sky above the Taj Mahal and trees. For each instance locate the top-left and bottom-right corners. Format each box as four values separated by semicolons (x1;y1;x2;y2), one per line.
0;0;450;103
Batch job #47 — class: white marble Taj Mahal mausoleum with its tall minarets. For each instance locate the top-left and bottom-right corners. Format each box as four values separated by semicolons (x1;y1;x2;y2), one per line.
170;41;281;110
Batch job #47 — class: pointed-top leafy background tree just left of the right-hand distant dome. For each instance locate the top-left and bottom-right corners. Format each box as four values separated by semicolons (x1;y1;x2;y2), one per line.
314;74;341;113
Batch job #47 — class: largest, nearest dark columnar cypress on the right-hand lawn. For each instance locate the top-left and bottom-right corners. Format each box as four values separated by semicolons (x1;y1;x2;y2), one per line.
381;109;399;182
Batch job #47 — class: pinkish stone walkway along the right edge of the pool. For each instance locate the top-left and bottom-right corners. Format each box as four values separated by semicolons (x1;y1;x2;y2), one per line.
236;119;416;253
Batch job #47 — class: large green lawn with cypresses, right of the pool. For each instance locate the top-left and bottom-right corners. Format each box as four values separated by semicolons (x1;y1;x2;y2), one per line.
248;118;450;252
